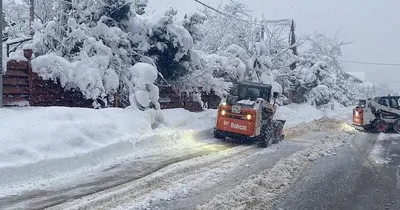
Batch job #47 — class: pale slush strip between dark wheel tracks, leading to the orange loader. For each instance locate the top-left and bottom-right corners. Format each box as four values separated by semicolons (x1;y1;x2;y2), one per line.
49;146;261;210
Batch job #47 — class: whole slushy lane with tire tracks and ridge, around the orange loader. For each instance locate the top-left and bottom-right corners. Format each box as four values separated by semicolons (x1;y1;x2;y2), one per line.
0;115;354;209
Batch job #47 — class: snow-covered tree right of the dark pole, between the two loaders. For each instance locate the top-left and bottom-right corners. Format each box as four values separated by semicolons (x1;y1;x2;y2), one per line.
290;33;374;106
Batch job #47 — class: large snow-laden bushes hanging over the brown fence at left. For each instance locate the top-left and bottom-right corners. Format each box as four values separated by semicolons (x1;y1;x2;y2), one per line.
25;0;193;108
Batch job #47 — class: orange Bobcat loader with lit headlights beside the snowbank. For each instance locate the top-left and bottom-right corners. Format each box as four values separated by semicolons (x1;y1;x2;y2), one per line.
214;82;286;147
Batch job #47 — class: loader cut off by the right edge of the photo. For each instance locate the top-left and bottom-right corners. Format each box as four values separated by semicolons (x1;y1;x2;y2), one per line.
353;95;400;133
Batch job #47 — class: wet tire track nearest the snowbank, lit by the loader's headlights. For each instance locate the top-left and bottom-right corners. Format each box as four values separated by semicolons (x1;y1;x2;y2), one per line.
0;143;244;210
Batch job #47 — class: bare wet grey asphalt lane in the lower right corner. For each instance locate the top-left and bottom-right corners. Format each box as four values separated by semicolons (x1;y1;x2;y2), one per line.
274;134;400;210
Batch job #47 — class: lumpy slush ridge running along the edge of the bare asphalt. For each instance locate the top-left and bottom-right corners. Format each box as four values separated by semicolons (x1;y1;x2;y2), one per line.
197;132;352;209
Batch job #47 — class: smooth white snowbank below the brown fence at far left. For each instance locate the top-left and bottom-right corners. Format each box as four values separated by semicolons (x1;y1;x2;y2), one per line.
0;107;157;168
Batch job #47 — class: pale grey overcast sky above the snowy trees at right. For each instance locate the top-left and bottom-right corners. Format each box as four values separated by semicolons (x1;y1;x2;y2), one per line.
149;0;400;90
